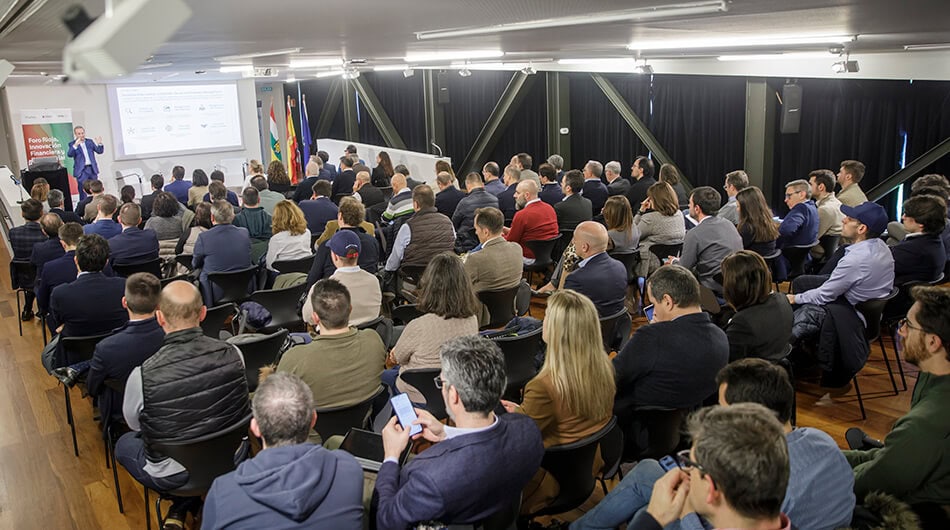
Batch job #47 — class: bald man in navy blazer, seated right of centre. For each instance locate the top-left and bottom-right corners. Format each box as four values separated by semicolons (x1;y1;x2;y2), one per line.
564;221;627;318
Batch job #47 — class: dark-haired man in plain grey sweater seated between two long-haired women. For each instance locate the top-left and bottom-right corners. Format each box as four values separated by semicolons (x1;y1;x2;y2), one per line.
672;186;742;294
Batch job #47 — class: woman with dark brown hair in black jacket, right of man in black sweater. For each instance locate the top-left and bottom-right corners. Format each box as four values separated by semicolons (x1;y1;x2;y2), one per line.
722;250;792;362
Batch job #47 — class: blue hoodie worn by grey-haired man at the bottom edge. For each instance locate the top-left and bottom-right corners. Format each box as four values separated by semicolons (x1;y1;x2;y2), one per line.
201;443;363;530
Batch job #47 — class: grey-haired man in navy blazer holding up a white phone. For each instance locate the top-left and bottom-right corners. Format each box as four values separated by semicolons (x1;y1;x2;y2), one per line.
376;336;544;530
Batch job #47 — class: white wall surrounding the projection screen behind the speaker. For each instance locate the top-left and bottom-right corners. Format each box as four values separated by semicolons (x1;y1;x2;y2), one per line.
0;79;262;194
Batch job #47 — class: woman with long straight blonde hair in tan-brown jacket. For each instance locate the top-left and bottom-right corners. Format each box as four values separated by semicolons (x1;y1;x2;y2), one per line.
501;290;616;513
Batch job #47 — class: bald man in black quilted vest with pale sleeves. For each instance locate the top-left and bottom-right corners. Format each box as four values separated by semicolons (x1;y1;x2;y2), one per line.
115;280;250;528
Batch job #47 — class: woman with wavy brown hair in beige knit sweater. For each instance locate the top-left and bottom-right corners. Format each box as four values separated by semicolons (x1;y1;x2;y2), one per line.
382;252;482;403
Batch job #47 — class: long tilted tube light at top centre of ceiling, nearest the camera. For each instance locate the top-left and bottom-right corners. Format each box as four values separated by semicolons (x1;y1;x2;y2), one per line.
416;0;729;40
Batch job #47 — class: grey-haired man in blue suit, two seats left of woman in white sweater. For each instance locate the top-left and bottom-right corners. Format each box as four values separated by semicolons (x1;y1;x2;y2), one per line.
192;200;251;307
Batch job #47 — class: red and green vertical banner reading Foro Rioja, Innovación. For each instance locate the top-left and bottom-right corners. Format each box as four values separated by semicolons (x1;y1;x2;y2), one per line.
20;109;79;195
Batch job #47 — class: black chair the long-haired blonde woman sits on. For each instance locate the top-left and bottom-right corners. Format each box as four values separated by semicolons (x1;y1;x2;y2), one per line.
528;418;617;518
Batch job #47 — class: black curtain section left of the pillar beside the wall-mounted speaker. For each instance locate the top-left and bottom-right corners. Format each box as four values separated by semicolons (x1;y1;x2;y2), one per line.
648;75;745;193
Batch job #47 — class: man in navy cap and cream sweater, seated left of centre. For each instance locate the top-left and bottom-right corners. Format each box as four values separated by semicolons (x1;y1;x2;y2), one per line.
302;230;383;326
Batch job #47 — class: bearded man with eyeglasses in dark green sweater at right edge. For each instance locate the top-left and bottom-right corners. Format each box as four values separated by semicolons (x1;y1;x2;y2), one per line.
844;286;950;516
